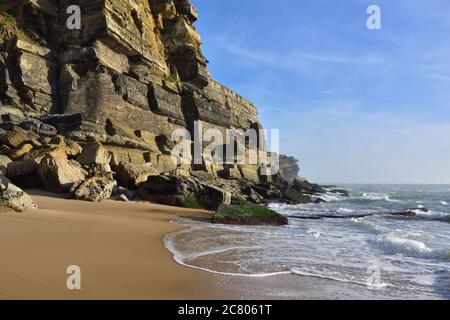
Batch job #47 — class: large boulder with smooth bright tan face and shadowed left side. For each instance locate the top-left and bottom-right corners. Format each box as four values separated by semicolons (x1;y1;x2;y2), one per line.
38;155;86;193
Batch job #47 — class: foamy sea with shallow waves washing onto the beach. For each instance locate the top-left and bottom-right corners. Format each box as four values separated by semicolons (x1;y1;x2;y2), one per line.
164;185;450;299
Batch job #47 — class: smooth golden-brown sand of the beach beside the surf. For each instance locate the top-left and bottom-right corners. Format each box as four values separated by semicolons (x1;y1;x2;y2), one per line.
0;191;232;299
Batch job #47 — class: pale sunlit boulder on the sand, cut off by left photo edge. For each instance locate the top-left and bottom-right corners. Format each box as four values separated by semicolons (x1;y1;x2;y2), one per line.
0;177;38;212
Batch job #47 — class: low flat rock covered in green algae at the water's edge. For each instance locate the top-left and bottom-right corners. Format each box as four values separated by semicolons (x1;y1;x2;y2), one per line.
213;203;288;226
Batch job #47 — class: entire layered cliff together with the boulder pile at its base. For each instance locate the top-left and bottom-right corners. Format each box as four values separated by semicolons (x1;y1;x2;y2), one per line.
0;0;324;214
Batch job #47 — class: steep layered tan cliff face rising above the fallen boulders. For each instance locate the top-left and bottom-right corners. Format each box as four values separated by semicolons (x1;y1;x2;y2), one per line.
0;0;258;171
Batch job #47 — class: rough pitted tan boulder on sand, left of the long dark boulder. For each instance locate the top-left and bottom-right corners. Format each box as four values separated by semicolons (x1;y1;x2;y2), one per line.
74;176;117;202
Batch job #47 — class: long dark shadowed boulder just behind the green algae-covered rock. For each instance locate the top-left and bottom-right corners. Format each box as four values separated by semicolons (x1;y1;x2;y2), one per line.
138;176;231;210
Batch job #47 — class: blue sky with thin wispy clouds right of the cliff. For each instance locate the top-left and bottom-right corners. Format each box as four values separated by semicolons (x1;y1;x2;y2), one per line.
191;0;450;184
